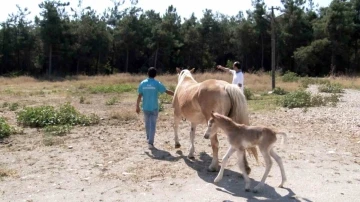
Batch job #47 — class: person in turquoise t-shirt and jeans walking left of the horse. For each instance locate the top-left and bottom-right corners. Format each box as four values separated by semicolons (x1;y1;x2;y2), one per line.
136;67;174;149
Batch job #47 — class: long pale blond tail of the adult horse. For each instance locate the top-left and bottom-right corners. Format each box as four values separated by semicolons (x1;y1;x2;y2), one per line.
225;84;258;161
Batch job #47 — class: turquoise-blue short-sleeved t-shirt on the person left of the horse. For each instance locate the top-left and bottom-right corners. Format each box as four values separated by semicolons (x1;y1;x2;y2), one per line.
138;78;166;111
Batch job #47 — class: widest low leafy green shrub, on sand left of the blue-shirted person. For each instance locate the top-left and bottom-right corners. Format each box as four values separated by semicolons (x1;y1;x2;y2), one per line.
17;103;99;127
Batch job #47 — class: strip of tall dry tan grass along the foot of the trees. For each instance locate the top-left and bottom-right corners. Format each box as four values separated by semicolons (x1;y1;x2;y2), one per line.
0;72;360;95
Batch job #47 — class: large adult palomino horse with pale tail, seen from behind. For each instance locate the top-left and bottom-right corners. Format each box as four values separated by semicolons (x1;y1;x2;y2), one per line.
172;68;257;173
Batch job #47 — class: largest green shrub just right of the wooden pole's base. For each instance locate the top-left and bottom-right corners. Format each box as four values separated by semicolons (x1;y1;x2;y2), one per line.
279;90;311;108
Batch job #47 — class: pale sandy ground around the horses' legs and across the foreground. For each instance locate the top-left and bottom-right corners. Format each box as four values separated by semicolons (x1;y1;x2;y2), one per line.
0;85;360;202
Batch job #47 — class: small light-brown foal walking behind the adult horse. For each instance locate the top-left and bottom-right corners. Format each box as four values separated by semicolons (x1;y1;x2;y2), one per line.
205;112;286;192
